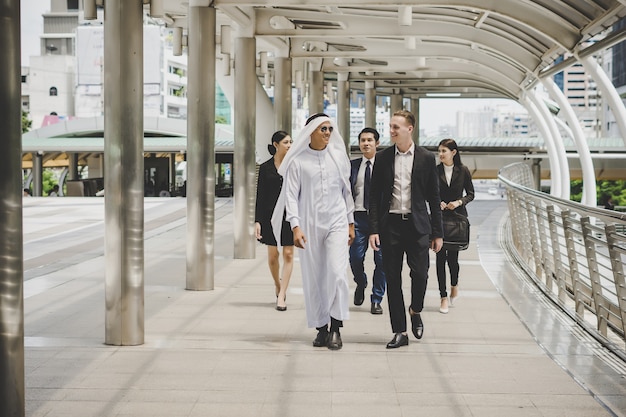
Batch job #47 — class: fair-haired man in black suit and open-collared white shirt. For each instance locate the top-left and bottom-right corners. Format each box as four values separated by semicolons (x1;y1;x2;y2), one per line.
369;110;443;349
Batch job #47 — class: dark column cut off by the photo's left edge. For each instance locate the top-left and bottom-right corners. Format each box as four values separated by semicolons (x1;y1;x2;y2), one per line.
0;1;26;417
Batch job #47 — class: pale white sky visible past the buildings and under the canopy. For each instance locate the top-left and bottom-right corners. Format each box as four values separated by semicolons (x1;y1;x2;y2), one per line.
20;0;521;135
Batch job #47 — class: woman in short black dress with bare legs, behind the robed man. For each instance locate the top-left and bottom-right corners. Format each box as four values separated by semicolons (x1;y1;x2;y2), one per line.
254;130;293;311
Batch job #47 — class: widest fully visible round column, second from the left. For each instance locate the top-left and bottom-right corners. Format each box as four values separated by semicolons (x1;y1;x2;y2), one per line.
104;0;144;345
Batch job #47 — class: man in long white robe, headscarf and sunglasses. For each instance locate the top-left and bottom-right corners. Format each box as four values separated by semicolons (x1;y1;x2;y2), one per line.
273;114;354;350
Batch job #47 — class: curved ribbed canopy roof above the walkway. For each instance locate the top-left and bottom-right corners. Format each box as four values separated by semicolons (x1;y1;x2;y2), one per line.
155;0;626;100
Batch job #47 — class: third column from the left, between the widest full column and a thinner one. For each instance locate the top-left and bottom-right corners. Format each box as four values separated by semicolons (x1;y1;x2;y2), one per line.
186;6;216;291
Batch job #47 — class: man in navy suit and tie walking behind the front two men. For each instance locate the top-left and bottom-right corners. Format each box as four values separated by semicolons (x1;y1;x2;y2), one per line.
350;127;386;314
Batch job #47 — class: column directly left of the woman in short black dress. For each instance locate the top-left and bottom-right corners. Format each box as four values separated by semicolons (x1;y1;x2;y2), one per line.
233;38;258;259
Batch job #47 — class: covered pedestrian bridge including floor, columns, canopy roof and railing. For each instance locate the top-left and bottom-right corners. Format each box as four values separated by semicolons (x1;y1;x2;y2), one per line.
0;0;626;416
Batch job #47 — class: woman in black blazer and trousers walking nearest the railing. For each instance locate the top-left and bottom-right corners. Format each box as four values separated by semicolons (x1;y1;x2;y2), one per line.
437;139;474;314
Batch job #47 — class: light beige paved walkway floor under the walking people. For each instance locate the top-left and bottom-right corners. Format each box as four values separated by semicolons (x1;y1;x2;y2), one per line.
24;198;626;417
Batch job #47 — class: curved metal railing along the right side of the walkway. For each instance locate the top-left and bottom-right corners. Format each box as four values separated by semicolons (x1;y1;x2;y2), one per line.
498;163;626;360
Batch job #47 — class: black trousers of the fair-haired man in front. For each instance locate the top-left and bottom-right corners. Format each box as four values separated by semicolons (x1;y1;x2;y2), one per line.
380;214;430;333
